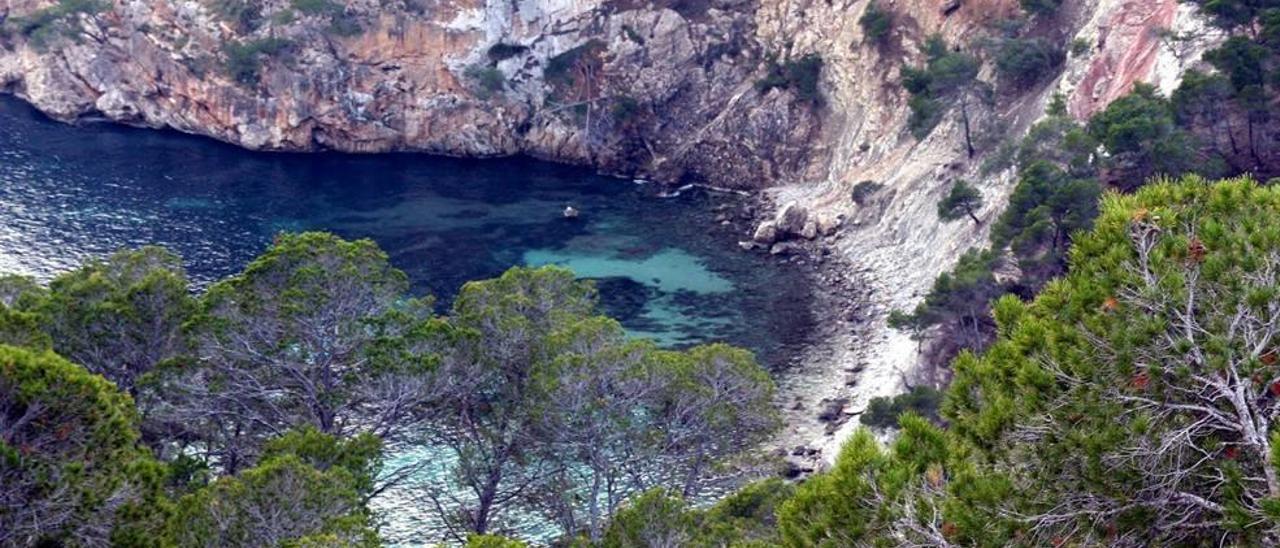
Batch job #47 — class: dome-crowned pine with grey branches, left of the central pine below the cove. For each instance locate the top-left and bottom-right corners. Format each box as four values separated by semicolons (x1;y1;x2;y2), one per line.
179;232;419;471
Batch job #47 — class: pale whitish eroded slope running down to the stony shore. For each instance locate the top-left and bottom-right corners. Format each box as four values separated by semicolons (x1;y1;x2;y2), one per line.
762;0;1220;461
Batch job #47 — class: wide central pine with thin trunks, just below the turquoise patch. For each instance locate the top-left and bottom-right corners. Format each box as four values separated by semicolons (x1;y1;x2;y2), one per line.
424;268;777;539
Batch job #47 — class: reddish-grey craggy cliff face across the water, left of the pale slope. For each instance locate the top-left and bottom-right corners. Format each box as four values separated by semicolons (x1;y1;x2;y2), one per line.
0;0;820;188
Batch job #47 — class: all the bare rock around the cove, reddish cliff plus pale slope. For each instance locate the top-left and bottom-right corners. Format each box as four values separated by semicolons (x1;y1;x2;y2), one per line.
0;0;1217;457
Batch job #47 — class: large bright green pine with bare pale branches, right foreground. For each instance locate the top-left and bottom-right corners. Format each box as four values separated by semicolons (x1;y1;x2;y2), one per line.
945;178;1280;545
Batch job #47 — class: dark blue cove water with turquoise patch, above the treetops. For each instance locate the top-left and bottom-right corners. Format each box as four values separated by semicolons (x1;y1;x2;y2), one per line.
0;96;810;365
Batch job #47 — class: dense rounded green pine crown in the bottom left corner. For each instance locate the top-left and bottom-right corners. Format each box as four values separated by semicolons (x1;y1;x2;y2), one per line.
0;346;152;545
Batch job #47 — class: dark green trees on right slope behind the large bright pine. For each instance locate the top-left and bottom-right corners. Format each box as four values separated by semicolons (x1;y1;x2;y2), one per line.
893;0;1280;391
